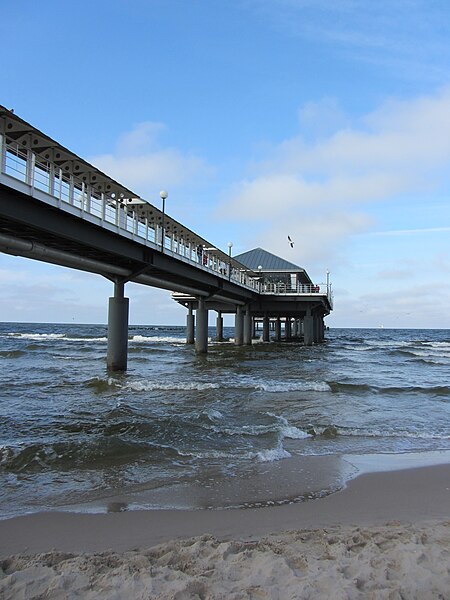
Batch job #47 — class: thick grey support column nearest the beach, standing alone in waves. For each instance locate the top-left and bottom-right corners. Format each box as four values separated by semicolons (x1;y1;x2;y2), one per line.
106;282;130;371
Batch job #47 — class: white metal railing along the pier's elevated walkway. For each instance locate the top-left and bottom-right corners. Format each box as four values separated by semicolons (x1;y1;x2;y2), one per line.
0;134;331;301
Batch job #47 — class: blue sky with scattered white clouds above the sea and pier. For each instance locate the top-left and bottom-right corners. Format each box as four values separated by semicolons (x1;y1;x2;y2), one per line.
0;0;450;328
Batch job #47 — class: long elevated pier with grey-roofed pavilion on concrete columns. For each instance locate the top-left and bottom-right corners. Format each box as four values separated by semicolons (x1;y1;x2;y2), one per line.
0;106;332;371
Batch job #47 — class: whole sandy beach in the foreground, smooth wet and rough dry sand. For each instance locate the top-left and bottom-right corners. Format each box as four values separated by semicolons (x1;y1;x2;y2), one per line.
0;465;450;600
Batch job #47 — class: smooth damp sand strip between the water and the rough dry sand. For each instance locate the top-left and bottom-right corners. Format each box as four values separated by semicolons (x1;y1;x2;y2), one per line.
0;464;450;557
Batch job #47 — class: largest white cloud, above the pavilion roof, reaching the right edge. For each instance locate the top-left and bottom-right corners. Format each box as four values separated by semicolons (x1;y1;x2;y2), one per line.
218;88;450;263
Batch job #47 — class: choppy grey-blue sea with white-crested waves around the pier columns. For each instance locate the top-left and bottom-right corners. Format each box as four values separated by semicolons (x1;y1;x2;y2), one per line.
0;323;450;518
